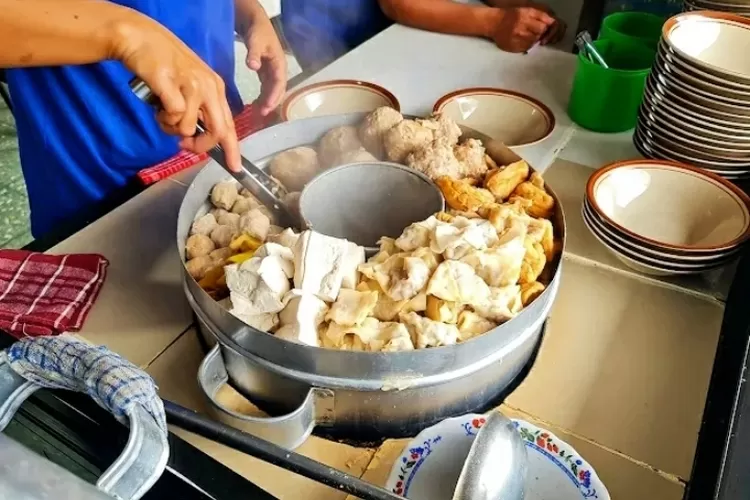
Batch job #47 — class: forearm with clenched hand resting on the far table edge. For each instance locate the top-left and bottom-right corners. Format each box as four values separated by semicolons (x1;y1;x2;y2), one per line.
379;0;556;52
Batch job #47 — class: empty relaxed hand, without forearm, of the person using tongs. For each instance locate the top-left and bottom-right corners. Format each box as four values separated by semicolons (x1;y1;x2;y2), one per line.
245;16;286;116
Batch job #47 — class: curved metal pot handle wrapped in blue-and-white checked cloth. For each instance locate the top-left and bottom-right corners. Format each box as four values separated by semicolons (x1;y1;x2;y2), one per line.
0;337;169;500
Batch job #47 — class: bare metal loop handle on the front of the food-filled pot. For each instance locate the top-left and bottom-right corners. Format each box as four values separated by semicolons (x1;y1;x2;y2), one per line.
198;344;333;450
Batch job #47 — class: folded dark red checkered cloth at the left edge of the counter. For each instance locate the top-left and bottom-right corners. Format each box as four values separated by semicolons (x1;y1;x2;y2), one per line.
0;250;109;339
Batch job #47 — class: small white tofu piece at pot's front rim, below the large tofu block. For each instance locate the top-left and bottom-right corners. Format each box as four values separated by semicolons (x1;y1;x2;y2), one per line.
276;290;328;347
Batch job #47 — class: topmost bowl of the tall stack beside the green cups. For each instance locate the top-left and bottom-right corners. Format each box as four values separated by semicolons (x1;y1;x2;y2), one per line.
662;11;750;84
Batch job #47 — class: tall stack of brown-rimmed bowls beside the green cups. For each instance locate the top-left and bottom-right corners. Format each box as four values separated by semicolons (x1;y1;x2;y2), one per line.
633;11;750;180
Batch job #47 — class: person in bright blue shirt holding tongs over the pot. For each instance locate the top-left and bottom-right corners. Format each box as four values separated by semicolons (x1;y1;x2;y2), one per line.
0;0;286;237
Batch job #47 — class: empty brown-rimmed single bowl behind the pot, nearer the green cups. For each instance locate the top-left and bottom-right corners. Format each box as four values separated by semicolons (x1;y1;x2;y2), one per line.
432;88;555;147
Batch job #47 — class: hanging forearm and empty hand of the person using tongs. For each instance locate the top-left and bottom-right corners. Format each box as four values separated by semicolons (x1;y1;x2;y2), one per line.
234;0;286;116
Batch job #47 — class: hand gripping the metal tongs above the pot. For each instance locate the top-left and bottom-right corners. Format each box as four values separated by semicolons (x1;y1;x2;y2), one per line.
111;14;242;171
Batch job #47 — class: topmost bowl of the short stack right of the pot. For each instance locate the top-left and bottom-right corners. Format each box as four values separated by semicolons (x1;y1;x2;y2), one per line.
586;160;750;253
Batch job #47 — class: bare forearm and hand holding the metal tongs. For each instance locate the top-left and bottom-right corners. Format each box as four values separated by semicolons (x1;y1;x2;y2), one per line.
0;0;240;169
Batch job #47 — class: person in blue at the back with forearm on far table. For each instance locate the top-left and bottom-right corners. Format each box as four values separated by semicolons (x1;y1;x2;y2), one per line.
281;0;565;71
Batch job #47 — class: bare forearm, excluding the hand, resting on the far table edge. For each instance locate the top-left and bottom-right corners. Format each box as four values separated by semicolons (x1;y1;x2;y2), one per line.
379;0;501;38
